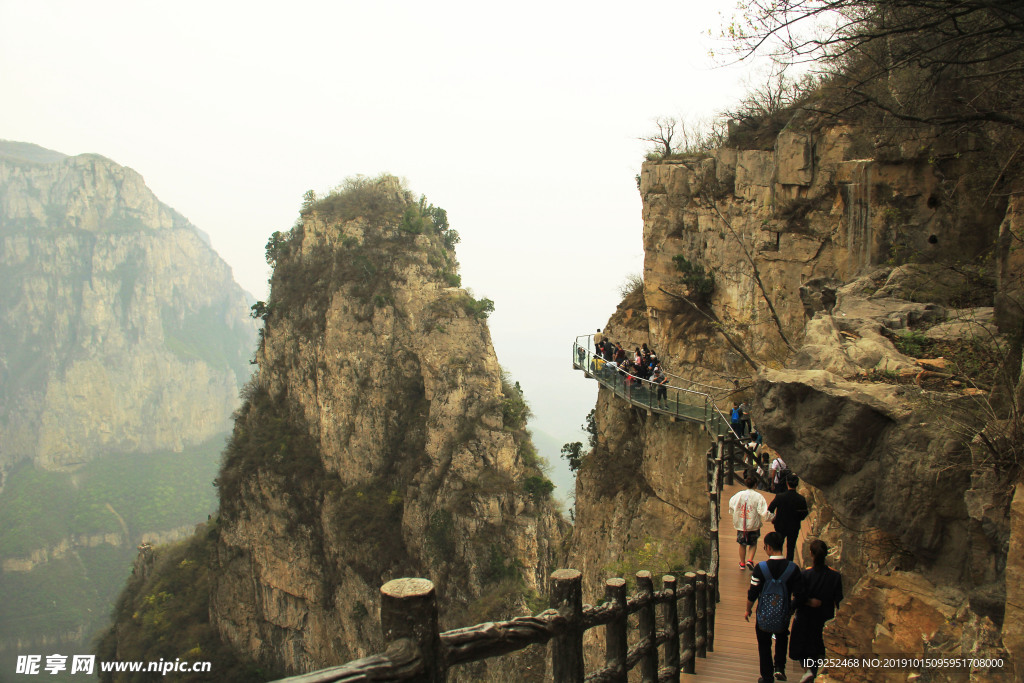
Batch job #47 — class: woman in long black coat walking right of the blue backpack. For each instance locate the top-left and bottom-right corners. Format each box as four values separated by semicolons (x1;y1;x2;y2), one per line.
790;541;843;683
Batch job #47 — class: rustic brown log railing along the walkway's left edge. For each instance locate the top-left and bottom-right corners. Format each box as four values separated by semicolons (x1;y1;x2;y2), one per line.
282;569;718;683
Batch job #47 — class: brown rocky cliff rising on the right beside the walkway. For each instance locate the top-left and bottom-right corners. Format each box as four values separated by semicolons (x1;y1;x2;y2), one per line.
573;117;1021;680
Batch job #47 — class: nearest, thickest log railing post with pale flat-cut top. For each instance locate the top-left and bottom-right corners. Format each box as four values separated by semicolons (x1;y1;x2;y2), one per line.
381;579;446;683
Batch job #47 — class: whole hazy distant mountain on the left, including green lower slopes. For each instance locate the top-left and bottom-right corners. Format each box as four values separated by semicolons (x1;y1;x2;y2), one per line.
0;141;256;671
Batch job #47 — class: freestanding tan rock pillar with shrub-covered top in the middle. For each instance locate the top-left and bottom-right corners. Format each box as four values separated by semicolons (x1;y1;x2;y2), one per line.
101;176;564;680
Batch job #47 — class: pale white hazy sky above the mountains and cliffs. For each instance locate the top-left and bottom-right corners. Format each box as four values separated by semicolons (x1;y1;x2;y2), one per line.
0;0;770;495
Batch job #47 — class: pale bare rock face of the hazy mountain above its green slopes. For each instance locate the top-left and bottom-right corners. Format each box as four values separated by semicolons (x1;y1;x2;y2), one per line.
0;142;255;471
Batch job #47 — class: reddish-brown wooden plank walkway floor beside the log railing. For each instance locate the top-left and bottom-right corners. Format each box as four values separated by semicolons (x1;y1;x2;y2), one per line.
682;485;807;683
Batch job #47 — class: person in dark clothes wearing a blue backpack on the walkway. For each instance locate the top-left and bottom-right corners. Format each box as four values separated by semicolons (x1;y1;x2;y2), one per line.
743;531;804;683
